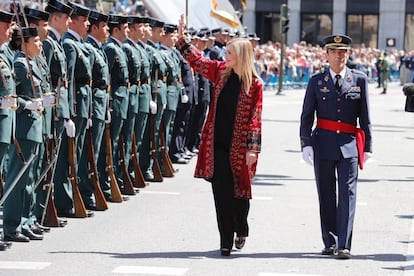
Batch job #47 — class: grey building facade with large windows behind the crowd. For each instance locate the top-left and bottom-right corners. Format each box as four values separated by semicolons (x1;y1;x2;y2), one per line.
236;0;414;50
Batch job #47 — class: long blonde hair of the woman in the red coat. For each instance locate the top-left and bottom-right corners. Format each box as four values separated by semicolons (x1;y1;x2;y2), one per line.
224;38;260;94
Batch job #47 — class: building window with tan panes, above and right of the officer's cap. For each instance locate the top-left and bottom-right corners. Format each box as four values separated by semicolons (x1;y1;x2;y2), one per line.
347;14;378;48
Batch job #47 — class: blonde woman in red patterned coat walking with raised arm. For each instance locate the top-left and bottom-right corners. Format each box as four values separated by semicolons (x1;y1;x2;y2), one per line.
176;19;263;256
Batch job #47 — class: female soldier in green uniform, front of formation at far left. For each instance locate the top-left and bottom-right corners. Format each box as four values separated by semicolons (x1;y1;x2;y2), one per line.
3;28;43;242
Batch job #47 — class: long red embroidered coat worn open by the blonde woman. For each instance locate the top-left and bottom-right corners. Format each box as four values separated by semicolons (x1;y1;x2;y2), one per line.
177;39;263;199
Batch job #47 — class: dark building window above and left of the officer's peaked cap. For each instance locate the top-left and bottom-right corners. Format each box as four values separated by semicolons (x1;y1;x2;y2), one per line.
301;14;332;45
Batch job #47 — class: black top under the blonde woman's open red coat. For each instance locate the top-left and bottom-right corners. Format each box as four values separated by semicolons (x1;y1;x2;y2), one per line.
214;72;241;150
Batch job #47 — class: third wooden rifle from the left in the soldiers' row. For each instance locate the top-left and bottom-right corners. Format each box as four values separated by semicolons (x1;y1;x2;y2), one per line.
86;128;108;211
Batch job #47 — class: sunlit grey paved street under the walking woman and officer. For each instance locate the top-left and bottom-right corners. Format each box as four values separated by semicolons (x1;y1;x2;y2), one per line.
0;83;414;276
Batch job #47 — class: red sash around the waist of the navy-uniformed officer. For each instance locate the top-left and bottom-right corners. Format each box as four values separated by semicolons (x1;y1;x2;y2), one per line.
316;118;365;170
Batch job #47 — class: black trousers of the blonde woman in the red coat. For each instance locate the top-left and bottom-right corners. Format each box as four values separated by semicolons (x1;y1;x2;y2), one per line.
212;148;250;249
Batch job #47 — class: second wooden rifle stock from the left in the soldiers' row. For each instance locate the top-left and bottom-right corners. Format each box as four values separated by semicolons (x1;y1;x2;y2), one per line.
68;137;88;218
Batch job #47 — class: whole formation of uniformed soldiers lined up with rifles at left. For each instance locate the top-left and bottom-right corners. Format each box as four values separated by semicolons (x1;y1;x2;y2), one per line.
0;0;247;250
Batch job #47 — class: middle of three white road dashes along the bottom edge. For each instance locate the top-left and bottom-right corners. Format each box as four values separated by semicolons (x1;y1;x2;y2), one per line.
112;265;188;275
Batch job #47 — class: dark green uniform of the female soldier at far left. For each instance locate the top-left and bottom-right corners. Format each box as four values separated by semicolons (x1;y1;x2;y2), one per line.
3;49;44;235
